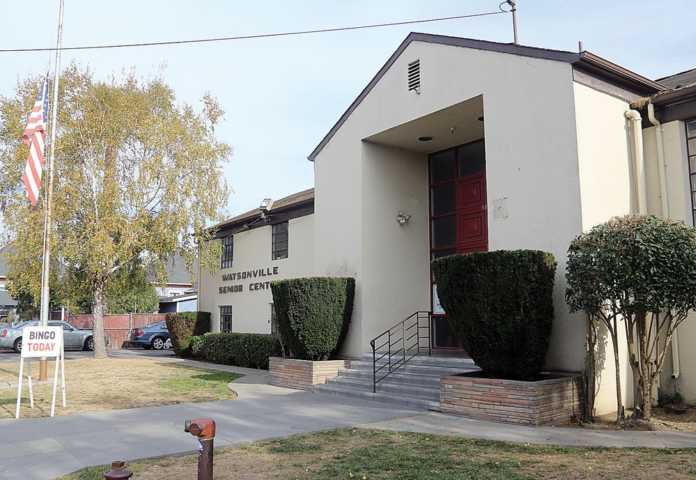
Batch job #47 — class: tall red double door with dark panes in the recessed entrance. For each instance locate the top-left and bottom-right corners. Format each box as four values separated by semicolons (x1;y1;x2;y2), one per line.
429;140;488;350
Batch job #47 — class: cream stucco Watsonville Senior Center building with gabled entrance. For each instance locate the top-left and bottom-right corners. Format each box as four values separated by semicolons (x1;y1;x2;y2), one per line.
200;33;696;413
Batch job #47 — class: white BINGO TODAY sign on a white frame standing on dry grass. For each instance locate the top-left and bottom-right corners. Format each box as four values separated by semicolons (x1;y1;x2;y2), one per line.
15;327;66;418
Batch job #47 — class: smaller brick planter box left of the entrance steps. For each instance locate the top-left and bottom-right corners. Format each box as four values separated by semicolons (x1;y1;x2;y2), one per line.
268;357;350;390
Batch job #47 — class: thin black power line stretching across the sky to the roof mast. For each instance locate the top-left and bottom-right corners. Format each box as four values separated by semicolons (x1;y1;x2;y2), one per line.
0;9;508;53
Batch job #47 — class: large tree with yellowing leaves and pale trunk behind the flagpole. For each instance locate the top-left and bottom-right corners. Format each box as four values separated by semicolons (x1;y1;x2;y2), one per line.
0;66;230;357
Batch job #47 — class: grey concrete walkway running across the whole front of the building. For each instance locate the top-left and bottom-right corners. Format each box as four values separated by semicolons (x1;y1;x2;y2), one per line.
5;353;696;480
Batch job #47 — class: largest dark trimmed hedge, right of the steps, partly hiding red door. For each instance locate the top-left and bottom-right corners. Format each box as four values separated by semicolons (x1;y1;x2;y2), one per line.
433;250;556;379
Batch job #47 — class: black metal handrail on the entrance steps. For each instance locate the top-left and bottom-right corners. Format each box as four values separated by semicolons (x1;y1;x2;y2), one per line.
370;310;432;393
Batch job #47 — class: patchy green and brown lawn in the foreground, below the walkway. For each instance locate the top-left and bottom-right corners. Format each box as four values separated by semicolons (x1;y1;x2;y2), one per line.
61;429;696;480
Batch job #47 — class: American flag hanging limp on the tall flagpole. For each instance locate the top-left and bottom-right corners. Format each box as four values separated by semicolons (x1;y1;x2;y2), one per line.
22;77;48;206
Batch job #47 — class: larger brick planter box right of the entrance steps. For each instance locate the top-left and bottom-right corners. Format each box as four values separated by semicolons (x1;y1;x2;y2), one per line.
440;372;580;425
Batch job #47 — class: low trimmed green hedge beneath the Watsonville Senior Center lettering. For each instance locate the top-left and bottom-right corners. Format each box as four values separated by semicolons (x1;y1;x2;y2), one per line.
190;333;280;370
